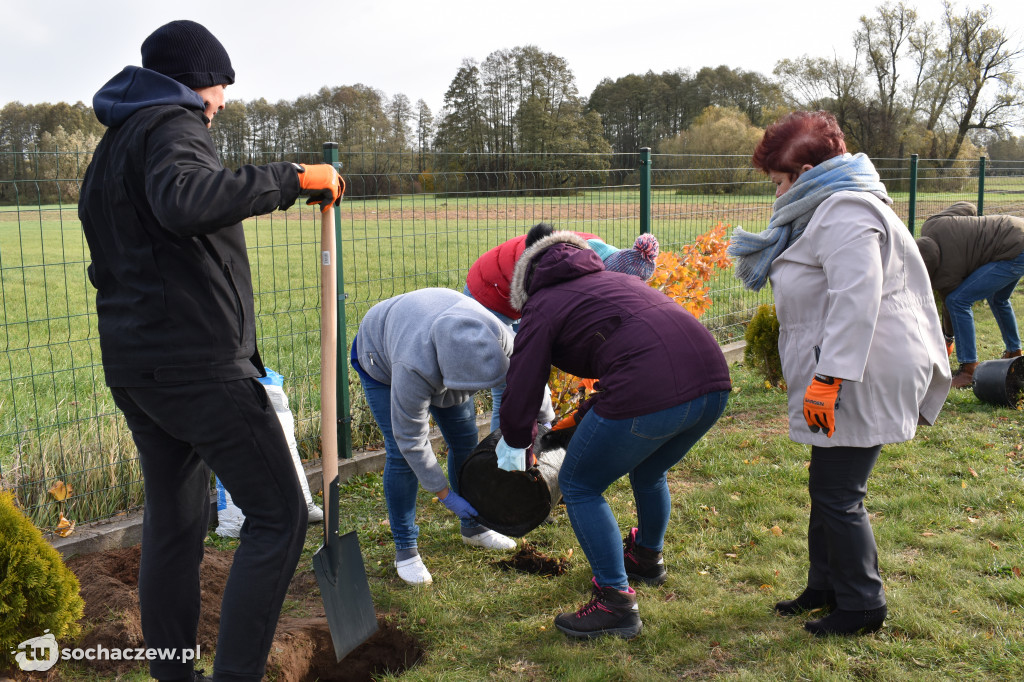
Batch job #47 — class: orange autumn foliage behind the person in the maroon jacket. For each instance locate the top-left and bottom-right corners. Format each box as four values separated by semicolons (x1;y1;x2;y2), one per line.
548;221;732;416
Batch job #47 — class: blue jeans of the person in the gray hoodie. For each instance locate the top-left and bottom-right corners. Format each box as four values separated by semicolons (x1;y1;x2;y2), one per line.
355;350;479;550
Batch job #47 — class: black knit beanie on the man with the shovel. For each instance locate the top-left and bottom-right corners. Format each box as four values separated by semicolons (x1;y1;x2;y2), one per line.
142;19;234;89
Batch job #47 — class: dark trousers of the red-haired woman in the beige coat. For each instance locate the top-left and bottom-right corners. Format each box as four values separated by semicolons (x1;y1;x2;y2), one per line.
807;445;886;610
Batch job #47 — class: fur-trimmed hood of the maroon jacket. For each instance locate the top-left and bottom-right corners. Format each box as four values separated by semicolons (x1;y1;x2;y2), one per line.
509;230;604;311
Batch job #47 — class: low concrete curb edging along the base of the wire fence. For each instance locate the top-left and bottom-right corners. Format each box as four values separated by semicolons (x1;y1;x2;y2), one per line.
48;341;746;558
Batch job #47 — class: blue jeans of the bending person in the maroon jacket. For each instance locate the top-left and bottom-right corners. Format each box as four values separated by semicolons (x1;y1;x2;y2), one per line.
558;391;729;590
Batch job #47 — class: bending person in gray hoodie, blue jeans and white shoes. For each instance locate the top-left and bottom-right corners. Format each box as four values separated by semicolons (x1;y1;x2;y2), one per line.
351;289;554;585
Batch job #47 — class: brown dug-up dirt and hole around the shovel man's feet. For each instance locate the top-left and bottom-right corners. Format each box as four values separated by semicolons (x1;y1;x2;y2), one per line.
47;545;424;682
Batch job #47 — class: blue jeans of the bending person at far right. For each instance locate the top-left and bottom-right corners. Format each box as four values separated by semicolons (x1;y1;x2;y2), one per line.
945;252;1024;365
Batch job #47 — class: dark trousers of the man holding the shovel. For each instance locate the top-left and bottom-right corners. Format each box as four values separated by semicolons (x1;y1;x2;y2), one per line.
111;379;306;680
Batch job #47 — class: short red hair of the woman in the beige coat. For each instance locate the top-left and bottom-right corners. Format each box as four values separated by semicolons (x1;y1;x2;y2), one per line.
751;112;846;176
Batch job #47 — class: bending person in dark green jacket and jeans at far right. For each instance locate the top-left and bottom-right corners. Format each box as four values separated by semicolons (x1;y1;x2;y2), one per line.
916;202;1024;388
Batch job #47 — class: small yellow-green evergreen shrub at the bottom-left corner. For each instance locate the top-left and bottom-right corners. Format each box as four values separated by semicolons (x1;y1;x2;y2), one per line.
0;492;85;672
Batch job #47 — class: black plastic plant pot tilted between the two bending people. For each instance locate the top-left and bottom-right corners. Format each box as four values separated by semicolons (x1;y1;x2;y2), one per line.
459;427;575;538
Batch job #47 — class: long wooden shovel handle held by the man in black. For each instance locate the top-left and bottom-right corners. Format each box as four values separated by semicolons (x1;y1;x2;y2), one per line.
321;206;338;528
